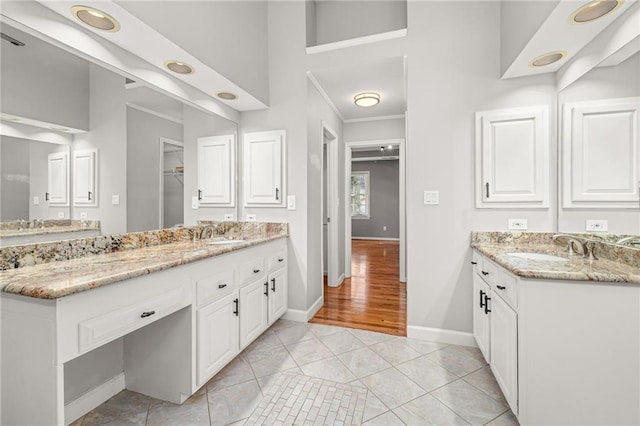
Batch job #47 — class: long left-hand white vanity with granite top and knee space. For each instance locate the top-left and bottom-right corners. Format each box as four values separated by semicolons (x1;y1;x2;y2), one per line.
1;225;287;425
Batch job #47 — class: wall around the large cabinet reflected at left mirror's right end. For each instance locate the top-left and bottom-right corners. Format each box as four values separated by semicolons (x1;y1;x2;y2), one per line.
182;105;241;225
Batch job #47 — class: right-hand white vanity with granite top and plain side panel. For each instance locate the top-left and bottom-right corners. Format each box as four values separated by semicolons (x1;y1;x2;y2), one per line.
471;233;640;425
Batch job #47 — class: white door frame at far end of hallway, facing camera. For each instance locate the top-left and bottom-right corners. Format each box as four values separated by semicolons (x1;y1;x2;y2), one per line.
344;138;407;283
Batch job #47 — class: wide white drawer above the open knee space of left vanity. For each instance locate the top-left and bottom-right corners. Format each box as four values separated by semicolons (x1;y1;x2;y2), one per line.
78;287;184;352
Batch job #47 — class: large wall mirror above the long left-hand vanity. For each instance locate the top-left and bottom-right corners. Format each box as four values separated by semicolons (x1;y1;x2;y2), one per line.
0;23;238;245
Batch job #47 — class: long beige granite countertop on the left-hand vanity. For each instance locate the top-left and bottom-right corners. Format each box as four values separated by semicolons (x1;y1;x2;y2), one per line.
0;233;287;299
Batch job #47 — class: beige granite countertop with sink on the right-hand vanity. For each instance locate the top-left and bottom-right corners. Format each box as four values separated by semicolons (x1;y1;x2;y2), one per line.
471;233;640;284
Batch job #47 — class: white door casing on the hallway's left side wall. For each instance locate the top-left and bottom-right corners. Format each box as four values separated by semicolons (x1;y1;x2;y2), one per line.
319;121;344;288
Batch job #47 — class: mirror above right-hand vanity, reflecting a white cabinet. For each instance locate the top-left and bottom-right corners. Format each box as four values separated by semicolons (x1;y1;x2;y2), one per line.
558;48;640;242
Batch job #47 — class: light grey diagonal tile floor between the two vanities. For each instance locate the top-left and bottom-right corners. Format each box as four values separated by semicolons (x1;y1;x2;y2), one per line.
73;320;518;426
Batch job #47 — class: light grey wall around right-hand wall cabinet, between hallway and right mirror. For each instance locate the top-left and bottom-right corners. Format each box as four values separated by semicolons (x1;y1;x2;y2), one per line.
406;1;556;333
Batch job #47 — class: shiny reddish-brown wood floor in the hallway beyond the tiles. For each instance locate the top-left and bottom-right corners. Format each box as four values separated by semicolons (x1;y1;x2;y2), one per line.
311;240;407;336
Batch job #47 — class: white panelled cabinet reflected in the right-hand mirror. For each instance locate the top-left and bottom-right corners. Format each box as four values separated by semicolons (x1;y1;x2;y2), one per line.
562;97;640;209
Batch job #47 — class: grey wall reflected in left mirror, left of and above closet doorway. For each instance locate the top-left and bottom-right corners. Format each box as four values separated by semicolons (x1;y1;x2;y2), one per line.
127;107;183;232
